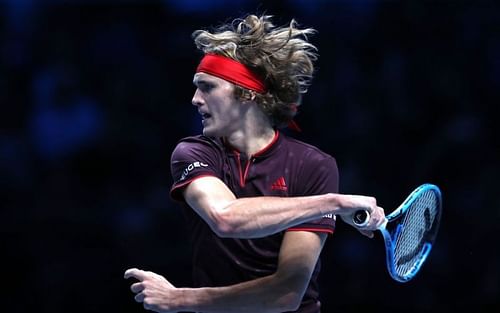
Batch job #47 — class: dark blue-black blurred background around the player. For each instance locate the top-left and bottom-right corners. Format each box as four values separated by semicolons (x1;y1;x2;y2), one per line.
0;0;500;313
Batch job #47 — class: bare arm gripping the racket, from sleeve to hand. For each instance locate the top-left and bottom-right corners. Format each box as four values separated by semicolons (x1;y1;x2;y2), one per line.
183;176;385;238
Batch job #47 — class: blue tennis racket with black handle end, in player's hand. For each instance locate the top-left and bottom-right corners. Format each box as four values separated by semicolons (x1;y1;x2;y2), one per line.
353;184;442;283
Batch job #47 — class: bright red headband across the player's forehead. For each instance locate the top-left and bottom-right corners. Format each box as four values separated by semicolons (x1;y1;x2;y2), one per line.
196;54;266;93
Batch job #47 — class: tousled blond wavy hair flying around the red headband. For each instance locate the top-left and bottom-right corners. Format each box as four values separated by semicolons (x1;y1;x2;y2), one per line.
193;15;318;127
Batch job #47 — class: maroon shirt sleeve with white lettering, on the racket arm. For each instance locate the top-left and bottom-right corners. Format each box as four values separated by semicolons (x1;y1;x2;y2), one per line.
170;138;220;201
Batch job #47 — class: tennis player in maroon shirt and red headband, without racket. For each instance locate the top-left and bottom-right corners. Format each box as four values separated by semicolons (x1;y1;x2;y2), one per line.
125;15;385;313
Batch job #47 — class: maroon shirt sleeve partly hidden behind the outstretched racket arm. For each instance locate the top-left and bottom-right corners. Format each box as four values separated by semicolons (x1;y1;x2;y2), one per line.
288;154;339;234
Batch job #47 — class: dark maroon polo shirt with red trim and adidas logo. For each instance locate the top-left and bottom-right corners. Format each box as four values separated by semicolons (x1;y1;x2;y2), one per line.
171;131;338;312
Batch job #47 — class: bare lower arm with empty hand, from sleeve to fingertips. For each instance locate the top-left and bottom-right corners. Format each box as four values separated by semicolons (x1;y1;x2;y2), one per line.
125;231;327;313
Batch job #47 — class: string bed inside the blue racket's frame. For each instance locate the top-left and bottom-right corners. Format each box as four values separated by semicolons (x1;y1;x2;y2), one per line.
394;190;439;277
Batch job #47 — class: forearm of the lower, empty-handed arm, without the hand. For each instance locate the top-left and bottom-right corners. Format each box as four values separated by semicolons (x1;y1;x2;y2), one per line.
176;275;304;313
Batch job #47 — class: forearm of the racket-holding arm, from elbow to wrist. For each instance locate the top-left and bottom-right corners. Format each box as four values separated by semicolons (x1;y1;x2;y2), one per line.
217;194;342;238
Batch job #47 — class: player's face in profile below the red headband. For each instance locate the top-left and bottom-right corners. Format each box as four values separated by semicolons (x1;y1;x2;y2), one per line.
191;73;243;137
